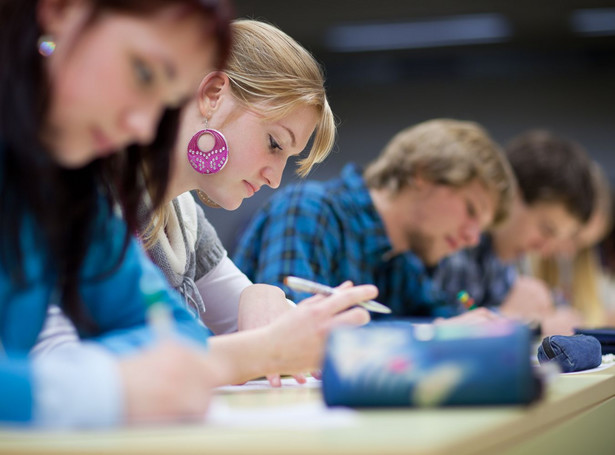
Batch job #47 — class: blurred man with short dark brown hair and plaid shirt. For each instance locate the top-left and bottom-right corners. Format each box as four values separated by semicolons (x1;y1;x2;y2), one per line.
436;130;595;334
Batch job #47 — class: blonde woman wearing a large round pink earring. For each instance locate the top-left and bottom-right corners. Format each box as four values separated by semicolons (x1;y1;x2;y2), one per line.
142;20;342;385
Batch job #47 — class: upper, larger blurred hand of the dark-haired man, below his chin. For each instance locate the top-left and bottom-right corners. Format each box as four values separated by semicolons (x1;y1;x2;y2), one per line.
500;276;555;321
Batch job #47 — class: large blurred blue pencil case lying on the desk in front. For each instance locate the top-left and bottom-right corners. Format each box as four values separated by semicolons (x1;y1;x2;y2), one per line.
322;322;541;407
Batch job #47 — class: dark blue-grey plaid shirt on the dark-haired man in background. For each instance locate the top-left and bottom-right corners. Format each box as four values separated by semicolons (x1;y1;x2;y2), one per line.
434;234;517;307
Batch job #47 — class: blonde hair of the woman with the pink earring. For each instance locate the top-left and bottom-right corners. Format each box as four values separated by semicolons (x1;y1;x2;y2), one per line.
223;19;335;177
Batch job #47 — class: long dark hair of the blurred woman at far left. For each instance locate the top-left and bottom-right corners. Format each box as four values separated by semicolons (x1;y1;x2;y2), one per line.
0;0;231;330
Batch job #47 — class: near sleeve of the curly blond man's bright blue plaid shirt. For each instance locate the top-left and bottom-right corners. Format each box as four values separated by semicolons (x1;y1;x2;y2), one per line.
233;185;341;302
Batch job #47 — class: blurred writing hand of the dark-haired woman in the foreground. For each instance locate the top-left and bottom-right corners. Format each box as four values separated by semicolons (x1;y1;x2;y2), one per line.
119;340;216;423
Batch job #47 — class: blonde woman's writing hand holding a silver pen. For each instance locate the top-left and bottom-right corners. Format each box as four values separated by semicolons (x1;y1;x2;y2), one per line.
268;283;378;375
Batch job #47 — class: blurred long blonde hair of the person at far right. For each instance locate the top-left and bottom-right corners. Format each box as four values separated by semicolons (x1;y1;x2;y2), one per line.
532;162;613;326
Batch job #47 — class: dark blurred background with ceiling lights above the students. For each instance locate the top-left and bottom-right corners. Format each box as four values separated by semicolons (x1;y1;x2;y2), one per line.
205;0;615;254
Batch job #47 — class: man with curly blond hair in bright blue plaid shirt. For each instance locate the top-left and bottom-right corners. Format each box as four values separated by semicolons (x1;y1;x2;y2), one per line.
234;119;513;316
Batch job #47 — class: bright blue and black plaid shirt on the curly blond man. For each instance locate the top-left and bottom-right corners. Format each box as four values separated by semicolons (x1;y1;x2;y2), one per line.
233;164;449;316
